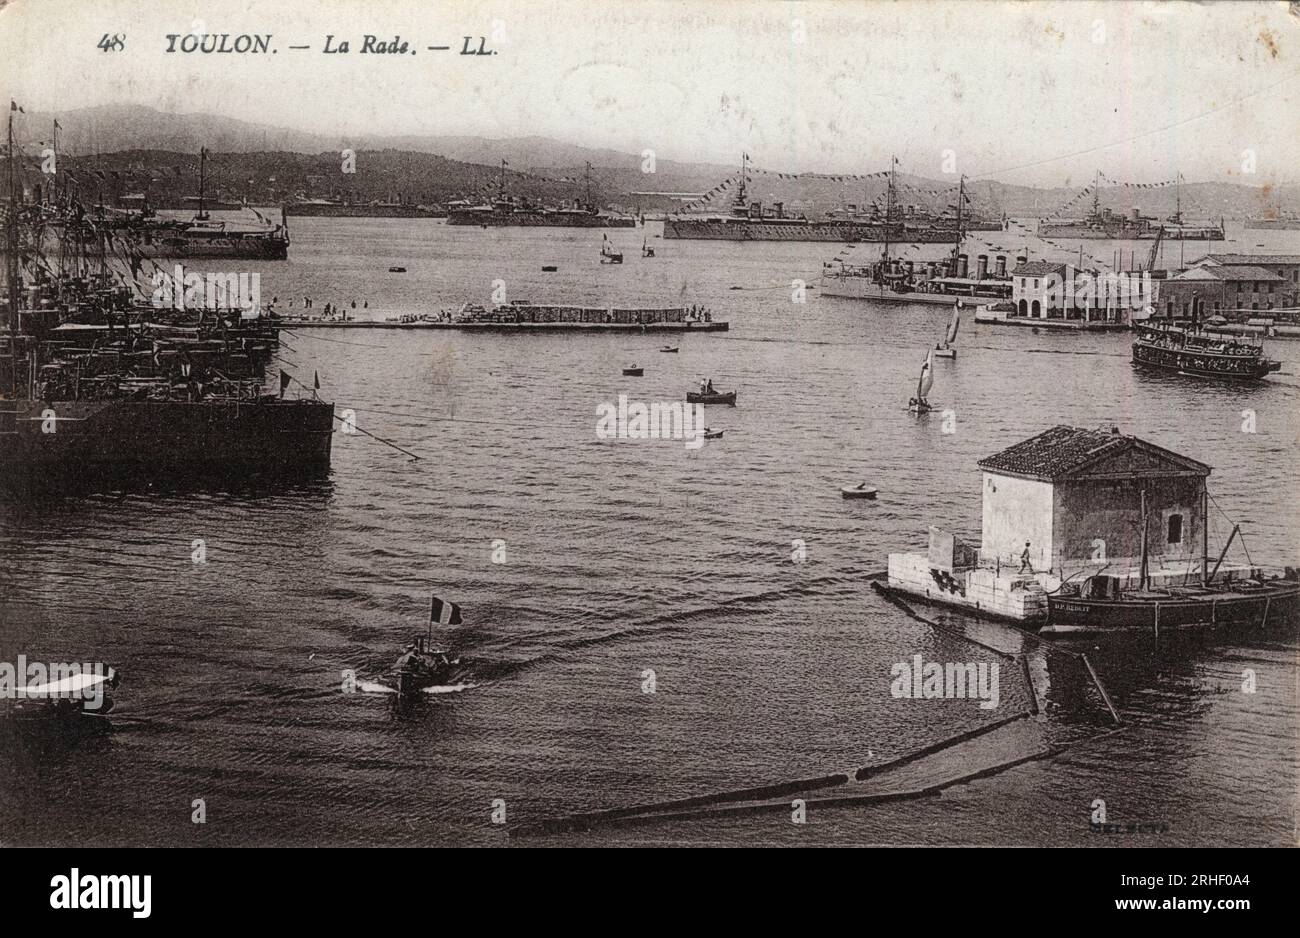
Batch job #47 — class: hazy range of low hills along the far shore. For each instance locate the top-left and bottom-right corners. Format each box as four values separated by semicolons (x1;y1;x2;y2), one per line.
16;105;1300;218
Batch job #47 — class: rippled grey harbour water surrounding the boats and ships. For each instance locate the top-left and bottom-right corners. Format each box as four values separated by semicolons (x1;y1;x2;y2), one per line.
0;218;1300;844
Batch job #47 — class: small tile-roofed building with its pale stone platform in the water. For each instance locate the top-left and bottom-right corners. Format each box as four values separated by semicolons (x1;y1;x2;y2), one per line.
888;426;1210;620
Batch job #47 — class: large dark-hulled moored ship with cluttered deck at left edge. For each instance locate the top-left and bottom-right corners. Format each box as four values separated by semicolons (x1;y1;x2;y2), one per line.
0;116;334;487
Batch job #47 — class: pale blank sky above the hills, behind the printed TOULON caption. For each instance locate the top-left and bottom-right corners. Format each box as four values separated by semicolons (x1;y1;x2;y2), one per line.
0;0;1300;186
